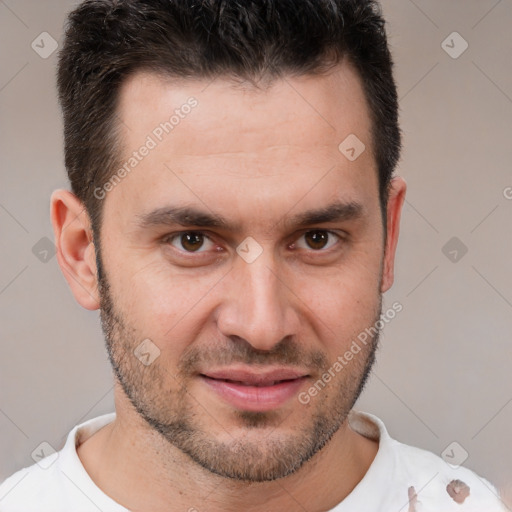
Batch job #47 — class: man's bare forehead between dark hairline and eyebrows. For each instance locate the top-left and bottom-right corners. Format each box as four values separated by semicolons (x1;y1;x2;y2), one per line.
107;63;377;228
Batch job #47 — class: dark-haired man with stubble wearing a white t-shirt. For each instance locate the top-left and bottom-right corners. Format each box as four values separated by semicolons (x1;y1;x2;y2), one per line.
0;0;505;512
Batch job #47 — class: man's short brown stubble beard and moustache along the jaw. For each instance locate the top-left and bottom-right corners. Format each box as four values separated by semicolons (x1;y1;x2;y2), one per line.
99;262;382;482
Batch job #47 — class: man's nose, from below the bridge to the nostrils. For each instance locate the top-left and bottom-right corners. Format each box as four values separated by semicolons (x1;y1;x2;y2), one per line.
217;255;299;350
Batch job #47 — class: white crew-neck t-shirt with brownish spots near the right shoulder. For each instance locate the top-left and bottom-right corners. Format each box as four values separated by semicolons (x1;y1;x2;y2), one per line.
0;411;507;512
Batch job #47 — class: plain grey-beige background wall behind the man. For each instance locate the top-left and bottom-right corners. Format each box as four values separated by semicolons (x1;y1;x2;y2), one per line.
0;0;512;500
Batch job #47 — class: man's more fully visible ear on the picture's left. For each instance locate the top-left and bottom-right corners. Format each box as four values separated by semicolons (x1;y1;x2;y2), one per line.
50;189;100;310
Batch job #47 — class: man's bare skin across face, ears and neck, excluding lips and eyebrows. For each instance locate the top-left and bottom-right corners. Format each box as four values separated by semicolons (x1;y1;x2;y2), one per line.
51;62;406;512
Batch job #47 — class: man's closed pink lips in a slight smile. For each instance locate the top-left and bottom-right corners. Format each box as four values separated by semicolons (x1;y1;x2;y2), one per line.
199;368;308;412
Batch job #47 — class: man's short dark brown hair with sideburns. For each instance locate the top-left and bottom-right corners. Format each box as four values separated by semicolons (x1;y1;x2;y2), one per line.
58;0;401;241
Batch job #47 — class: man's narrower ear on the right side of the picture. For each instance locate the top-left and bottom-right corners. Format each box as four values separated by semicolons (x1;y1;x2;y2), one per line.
380;176;407;293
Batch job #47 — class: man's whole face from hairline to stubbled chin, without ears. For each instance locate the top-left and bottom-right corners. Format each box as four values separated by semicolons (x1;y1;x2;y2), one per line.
98;65;384;481
